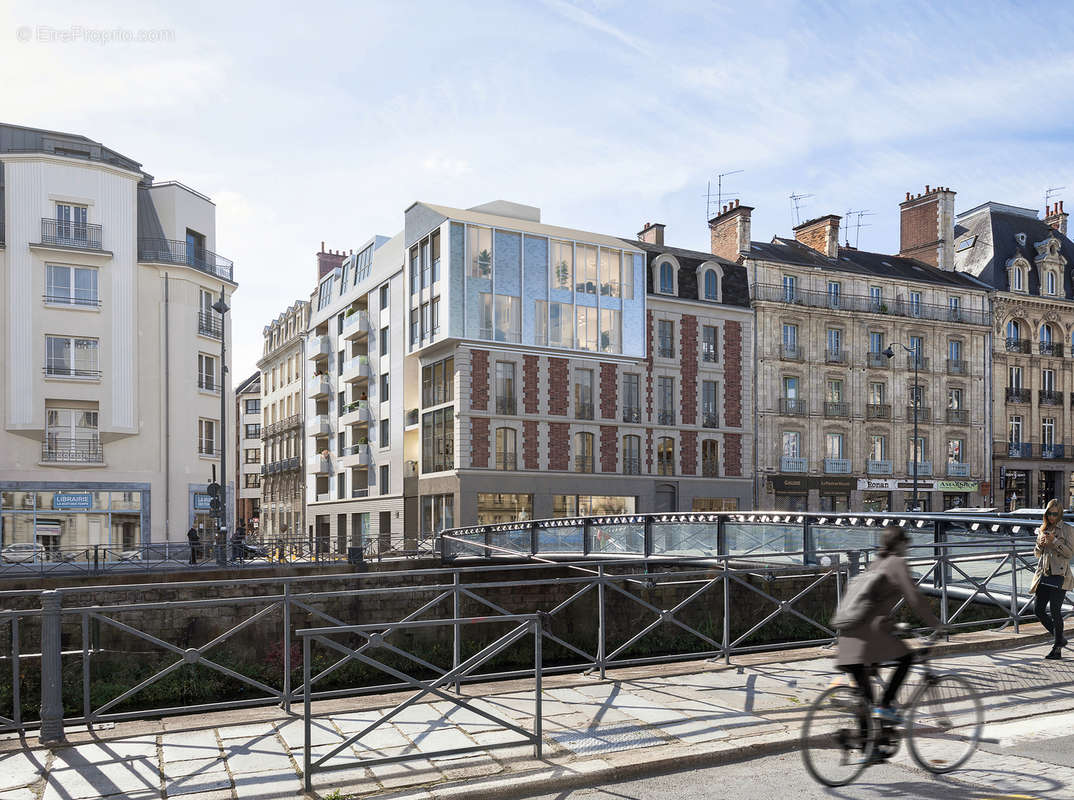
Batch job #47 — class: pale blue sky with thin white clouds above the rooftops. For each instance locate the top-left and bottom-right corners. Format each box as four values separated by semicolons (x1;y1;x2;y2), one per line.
0;0;1074;381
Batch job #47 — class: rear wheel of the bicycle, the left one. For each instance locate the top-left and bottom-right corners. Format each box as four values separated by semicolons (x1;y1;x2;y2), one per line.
801;686;875;786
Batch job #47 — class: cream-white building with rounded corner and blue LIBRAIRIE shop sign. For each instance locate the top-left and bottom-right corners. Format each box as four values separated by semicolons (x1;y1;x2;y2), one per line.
0;125;236;551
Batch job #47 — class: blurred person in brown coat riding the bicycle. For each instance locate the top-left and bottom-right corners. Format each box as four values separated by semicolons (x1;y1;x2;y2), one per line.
836;525;940;724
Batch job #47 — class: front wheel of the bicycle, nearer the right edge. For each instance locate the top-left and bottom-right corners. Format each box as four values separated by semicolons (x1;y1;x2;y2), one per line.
906;674;985;774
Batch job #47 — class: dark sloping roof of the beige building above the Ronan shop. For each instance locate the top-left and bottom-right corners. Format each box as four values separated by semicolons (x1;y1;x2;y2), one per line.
750;236;989;291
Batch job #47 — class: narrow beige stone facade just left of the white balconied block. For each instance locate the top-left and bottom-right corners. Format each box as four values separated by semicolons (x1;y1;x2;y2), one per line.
258;300;309;540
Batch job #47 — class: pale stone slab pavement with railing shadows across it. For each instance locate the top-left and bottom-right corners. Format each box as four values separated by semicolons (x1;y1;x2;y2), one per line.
0;631;1074;800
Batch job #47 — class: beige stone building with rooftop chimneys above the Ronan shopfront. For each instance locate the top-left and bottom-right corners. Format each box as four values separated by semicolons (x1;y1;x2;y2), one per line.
710;192;991;511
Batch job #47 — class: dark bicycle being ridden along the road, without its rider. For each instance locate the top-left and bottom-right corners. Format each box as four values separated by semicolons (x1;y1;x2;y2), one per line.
800;626;985;786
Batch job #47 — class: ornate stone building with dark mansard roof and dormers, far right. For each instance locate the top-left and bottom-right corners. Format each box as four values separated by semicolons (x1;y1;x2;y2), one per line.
948;196;1074;508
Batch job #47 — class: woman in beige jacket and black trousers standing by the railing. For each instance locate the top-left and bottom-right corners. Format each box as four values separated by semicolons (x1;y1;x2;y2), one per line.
1029;499;1074;659
